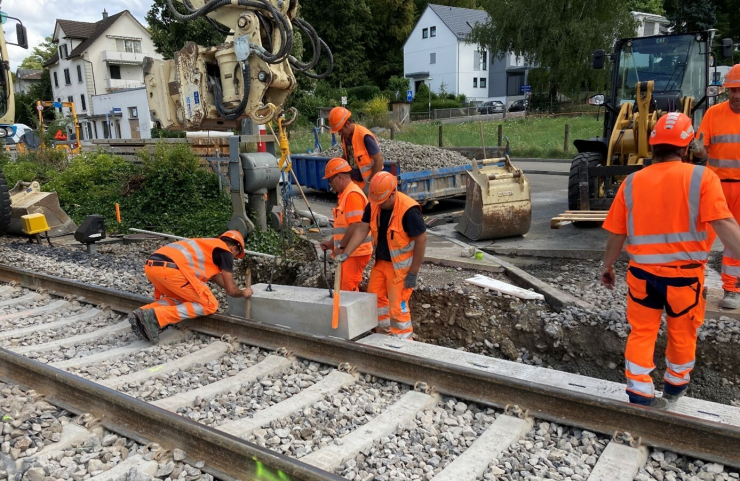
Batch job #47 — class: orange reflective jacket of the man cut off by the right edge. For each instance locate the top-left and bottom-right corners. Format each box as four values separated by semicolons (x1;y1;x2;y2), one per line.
699;102;740;180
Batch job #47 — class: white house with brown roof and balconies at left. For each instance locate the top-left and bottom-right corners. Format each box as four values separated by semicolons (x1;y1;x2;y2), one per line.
44;10;161;140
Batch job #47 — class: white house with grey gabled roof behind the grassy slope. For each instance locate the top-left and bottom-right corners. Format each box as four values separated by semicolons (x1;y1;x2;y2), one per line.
403;4;530;104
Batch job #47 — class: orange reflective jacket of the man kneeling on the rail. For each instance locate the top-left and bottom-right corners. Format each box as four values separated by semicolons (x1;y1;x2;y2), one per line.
155;239;229;282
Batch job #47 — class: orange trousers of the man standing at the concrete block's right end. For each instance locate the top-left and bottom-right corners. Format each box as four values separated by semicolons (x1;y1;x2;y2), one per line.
367;259;414;339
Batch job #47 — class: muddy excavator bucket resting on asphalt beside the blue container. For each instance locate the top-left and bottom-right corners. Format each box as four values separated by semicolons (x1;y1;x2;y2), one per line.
456;156;532;241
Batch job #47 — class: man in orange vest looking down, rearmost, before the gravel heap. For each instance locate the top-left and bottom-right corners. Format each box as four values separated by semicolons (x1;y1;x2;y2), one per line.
329;107;383;193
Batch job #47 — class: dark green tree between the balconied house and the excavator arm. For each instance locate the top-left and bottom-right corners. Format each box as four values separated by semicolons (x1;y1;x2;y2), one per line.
146;0;225;58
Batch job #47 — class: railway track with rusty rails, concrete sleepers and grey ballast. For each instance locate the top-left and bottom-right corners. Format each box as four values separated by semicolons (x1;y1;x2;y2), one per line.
0;267;740;481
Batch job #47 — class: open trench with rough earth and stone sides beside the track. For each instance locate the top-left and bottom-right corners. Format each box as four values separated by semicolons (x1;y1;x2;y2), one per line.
238;248;740;405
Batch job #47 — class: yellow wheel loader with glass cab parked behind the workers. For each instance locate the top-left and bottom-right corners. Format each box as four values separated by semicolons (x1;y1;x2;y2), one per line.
551;30;733;228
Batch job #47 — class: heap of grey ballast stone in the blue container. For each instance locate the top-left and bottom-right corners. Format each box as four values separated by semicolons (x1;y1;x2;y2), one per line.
315;138;470;172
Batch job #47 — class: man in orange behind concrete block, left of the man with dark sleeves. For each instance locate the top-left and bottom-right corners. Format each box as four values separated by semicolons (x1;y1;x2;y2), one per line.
321;158;373;291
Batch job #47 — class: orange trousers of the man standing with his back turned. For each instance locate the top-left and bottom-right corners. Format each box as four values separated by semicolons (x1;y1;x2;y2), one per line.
624;265;705;404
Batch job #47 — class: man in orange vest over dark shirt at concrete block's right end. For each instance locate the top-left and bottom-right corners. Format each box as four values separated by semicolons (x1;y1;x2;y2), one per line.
335;172;427;339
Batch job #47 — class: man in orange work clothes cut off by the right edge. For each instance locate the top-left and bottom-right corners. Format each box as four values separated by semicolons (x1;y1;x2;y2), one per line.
692;64;740;309
